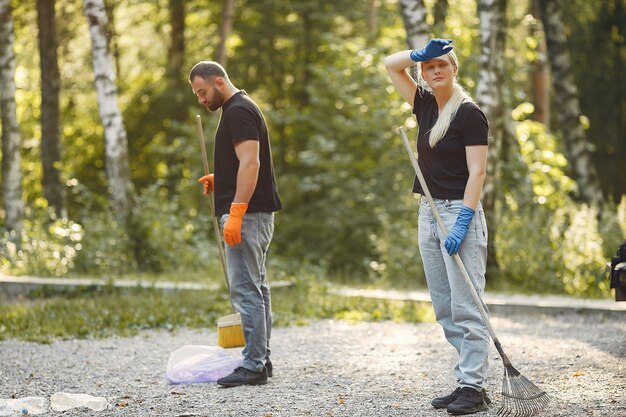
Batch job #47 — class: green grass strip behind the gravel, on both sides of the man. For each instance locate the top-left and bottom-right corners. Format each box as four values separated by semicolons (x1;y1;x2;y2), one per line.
0;276;433;343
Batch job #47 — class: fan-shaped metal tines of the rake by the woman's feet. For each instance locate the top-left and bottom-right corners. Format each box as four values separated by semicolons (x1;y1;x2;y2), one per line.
498;358;550;417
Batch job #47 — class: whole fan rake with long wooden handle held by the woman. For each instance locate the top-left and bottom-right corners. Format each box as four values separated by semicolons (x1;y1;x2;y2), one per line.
398;127;550;417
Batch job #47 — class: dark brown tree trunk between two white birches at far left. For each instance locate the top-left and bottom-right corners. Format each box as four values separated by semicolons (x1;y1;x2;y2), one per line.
37;0;67;218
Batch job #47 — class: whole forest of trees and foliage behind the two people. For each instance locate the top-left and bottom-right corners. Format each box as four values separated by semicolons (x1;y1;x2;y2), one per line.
0;0;626;297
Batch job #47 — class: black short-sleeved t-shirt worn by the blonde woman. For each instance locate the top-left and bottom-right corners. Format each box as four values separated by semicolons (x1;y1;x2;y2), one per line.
413;86;489;200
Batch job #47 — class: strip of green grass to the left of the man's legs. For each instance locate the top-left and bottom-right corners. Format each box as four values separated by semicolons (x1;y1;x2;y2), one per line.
0;286;229;342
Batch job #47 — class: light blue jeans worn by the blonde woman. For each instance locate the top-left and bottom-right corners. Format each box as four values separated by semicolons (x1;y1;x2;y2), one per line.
418;197;490;389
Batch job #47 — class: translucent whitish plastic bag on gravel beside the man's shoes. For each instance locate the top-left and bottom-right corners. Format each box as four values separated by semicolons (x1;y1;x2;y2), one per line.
166;345;243;384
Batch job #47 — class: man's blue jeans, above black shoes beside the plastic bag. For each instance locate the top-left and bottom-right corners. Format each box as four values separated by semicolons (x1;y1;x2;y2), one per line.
220;213;274;372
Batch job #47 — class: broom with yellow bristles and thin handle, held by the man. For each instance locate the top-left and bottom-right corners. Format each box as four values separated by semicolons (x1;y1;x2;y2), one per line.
196;114;246;349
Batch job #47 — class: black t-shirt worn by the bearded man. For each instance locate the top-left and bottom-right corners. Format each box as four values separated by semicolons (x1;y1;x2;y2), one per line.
214;90;282;217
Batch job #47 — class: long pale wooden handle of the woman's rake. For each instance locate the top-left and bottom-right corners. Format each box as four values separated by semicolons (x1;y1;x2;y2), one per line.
398;126;510;365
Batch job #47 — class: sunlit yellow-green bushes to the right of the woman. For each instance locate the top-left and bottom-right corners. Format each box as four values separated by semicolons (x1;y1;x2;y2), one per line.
495;114;626;297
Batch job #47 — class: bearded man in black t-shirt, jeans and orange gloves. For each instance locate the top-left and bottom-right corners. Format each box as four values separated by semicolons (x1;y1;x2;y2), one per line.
189;61;282;387
